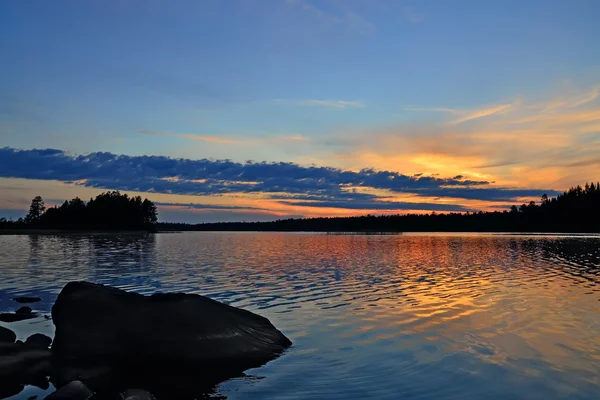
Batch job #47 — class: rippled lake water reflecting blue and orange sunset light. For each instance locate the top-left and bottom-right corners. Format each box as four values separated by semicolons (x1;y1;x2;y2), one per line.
0;233;600;400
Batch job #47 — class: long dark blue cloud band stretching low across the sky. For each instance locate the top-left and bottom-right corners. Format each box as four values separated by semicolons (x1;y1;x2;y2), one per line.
0;147;556;211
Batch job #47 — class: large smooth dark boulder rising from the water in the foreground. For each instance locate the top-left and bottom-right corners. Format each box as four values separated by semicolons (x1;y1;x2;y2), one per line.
52;282;291;371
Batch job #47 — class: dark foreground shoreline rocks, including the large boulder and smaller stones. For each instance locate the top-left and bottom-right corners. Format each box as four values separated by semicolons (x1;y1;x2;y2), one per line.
0;282;291;400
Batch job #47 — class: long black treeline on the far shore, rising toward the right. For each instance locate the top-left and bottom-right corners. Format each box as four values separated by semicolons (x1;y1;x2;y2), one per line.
157;183;600;232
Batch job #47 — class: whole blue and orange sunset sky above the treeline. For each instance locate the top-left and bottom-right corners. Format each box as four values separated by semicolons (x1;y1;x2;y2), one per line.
0;0;600;223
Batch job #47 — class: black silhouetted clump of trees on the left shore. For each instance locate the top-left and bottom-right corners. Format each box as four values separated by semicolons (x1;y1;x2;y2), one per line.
0;191;158;231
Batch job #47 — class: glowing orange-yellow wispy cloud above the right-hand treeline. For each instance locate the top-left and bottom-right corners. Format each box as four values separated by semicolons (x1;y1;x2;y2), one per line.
332;85;600;189
